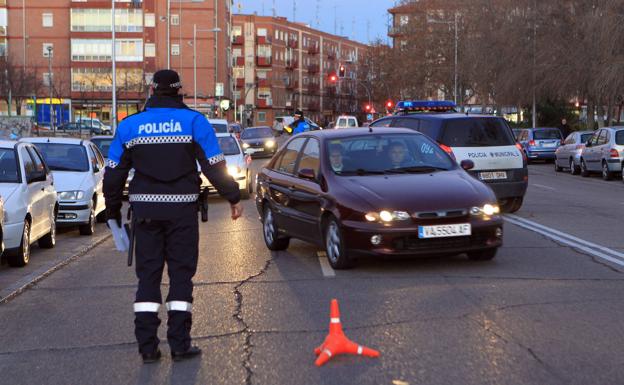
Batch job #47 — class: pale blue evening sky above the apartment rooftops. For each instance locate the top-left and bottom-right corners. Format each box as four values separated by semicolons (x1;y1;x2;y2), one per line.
234;0;396;43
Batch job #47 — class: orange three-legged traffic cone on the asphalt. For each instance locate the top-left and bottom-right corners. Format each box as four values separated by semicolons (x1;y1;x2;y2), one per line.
314;299;379;366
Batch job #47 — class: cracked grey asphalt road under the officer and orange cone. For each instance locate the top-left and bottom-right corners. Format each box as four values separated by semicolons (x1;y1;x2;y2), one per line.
0;160;624;385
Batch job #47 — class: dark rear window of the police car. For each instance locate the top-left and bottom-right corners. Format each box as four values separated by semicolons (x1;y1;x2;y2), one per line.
441;117;516;147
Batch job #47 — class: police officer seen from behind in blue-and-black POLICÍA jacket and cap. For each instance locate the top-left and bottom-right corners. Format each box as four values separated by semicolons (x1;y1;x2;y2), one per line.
104;70;242;363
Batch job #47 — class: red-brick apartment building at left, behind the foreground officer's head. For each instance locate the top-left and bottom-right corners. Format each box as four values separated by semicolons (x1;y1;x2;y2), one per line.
0;0;232;121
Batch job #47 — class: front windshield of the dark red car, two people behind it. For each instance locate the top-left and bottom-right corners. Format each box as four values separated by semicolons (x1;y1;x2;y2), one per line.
326;134;455;175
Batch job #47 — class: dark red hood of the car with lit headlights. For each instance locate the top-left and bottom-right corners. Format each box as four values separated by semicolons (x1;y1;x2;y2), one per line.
343;170;496;212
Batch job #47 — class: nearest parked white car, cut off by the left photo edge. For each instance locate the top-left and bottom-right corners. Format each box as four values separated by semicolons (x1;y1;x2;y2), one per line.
0;141;58;267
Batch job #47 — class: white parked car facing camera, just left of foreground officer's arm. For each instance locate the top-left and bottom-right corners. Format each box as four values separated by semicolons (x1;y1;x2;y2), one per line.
23;138;106;235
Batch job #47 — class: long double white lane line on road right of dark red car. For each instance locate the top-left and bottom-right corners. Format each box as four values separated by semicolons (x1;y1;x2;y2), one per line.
504;214;624;266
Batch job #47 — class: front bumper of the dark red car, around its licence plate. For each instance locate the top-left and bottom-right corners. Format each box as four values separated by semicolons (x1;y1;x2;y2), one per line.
342;217;503;256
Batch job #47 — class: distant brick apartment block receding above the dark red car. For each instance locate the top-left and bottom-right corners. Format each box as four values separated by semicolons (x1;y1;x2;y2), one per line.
232;15;367;125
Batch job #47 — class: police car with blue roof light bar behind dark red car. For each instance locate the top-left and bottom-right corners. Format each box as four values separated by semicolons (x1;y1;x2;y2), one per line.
370;101;528;212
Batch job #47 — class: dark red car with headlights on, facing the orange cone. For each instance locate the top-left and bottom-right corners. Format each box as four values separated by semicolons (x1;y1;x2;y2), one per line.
256;128;503;269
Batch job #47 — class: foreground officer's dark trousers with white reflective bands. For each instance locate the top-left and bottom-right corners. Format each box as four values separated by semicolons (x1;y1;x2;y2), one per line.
134;214;199;353
